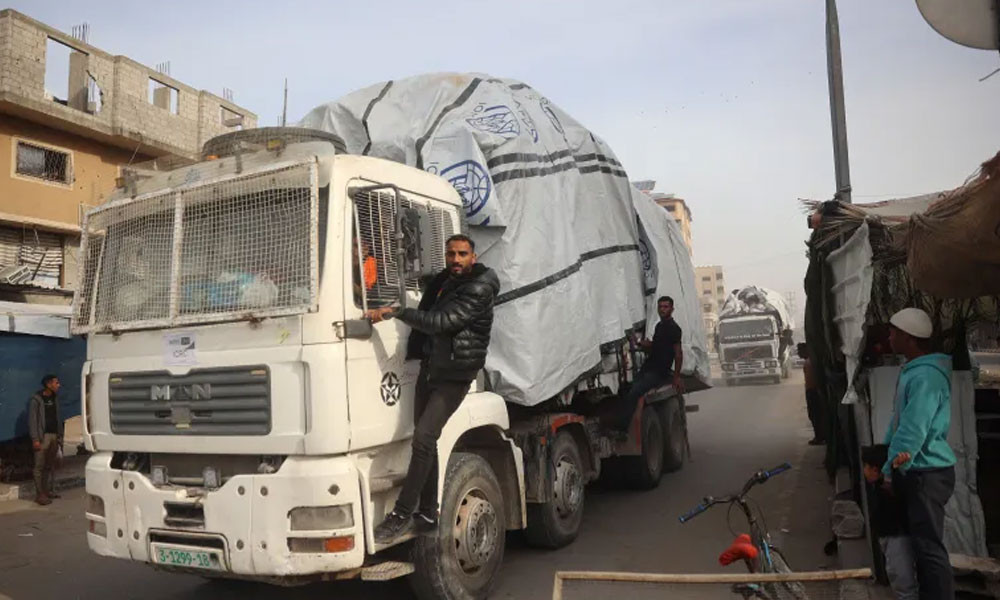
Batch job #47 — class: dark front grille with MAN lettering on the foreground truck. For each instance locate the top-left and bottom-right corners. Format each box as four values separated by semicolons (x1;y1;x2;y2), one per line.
108;366;271;435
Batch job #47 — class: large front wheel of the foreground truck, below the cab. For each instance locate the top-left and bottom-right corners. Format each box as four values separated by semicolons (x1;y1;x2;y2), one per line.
410;452;507;600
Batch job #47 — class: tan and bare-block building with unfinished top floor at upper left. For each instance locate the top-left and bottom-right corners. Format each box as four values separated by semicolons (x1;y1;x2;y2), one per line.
0;9;257;304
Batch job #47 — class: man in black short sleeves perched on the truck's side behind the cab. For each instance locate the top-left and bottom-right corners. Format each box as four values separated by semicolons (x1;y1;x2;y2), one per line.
616;296;684;431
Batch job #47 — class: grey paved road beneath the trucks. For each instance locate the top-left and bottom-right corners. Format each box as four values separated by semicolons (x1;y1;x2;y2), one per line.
0;371;832;600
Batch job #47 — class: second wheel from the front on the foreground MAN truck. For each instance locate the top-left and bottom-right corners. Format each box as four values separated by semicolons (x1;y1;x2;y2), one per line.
524;431;585;549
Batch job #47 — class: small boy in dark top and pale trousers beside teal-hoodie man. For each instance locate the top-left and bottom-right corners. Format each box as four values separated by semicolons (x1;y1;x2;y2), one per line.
861;444;919;600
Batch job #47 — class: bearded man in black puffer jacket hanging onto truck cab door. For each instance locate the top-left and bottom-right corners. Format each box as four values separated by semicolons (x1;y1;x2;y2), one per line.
368;235;500;544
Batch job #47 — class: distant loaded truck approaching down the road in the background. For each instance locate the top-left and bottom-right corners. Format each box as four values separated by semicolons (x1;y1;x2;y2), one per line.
717;286;794;385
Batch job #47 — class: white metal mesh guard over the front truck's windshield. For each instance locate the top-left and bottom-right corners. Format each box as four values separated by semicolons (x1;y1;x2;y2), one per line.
73;161;319;333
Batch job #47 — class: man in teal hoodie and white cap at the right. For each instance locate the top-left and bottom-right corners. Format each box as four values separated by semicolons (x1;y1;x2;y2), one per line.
882;308;955;600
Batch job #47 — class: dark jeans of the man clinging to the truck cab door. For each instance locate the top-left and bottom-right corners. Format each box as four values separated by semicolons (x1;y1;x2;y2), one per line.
395;367;472;517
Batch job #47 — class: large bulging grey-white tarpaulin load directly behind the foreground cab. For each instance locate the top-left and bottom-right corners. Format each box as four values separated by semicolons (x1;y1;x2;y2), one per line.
298;73;712;406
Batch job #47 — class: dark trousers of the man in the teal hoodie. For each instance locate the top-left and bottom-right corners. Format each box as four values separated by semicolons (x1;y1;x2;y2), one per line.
901;467;955;600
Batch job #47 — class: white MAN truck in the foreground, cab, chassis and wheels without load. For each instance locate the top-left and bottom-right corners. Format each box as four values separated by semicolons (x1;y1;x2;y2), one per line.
74;128;687;599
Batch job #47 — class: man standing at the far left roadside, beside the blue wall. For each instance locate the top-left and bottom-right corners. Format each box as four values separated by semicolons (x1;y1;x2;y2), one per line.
28;375;63;506
